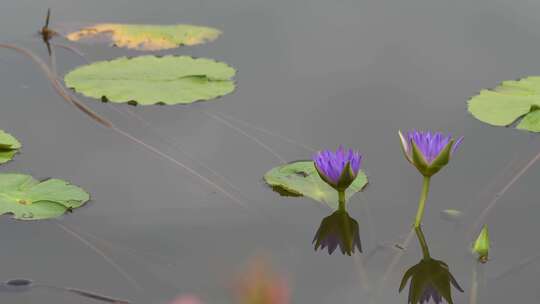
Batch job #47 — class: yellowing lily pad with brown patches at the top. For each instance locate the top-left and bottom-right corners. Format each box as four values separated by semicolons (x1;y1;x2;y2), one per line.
65;23;221;51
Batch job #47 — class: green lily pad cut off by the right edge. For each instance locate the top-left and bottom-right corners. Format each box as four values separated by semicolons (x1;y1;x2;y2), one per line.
468;76;540;132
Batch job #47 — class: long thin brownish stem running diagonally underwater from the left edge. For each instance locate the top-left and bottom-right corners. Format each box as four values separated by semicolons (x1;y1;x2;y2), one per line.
0;43;247;207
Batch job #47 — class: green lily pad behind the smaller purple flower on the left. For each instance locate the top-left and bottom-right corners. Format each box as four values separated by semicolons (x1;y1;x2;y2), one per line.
264;161;368;209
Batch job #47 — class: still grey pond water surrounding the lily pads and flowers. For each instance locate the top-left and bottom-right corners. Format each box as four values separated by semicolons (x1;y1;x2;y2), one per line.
0;0;540;304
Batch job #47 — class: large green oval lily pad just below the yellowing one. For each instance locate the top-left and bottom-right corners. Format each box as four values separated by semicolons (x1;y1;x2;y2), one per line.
64;56;236;105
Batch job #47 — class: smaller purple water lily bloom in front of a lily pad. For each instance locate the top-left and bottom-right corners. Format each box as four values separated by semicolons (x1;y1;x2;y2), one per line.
313;146;362;191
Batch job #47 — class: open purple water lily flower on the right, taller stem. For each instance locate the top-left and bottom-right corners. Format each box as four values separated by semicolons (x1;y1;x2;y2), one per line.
399;130;463;176
